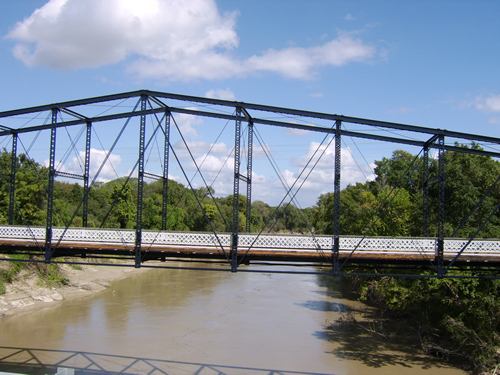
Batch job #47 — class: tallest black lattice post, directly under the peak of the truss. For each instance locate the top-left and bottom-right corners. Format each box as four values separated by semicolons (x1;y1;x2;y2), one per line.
135;95;147;268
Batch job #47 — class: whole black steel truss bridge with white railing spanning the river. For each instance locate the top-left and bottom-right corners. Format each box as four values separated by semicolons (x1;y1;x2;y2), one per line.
0;90;500;277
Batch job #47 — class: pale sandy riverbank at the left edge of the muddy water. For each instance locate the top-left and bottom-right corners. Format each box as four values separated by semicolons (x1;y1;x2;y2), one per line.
0;265;147;319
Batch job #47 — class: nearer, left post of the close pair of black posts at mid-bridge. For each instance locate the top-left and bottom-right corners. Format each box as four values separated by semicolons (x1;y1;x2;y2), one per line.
230;107;242;272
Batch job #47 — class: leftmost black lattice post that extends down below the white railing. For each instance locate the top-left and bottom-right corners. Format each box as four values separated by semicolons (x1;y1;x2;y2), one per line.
45;108;59;263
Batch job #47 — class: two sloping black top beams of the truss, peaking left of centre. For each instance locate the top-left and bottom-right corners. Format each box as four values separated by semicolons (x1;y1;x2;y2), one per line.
0;90;500;157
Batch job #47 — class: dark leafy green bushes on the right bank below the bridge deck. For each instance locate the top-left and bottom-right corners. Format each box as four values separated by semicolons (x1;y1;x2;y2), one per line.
361;277;500;373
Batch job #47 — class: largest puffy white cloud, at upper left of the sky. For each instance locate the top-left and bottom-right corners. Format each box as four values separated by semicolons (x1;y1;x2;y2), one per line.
8;0;238;69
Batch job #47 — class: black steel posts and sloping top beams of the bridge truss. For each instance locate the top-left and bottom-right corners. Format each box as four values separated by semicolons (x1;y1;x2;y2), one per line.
0;90;500;277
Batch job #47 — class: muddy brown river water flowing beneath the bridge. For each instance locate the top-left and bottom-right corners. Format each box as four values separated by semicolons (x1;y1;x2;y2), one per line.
0;270;462;375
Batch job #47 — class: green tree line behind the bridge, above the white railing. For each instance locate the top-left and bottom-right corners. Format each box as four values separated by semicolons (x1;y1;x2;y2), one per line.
0;146;500;238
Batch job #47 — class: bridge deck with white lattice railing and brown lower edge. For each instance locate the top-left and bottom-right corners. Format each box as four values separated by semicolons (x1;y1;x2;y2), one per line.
0;226;500;264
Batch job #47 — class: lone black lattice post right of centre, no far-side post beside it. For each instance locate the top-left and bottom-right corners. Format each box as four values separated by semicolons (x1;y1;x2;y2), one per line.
332;120;342;274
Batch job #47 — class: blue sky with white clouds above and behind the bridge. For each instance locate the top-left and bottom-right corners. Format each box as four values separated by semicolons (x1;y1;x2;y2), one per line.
0;0;500;206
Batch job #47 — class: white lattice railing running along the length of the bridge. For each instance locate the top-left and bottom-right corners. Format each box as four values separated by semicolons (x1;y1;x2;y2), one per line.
0;226;500;256
